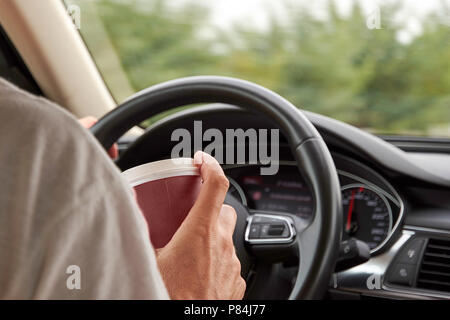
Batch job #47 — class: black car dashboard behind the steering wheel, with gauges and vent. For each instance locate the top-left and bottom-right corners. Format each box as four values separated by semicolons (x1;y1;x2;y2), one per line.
118;104;450;299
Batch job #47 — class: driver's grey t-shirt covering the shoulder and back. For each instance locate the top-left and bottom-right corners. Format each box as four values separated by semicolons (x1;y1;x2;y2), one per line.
0;79;168;299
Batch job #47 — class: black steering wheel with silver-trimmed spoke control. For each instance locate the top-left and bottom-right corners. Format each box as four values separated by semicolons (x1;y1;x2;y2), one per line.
91;76;342;299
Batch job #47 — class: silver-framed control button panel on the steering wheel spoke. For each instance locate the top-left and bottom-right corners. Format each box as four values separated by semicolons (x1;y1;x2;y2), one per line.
245;214;295;244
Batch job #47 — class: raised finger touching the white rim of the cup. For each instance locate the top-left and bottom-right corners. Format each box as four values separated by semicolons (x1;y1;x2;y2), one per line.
189;151;229;219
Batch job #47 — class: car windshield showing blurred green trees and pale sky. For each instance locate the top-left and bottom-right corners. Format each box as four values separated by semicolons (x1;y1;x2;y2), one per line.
65;0;450;137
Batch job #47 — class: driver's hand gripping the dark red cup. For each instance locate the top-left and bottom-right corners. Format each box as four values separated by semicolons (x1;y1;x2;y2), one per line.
156;152;246;300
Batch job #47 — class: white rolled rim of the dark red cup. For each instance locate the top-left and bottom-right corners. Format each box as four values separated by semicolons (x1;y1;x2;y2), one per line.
122;158;200;187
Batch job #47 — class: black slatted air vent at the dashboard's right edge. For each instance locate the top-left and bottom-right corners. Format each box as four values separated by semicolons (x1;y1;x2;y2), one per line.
417;239;450;292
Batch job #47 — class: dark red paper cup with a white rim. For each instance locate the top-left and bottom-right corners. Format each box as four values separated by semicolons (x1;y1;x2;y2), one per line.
122;158;201;248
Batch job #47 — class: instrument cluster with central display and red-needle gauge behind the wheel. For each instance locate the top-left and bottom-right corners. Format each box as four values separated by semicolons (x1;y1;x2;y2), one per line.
225;155;404;254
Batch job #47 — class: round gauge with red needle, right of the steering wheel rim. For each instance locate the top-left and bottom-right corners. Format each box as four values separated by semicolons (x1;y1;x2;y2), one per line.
342;184;393;251
